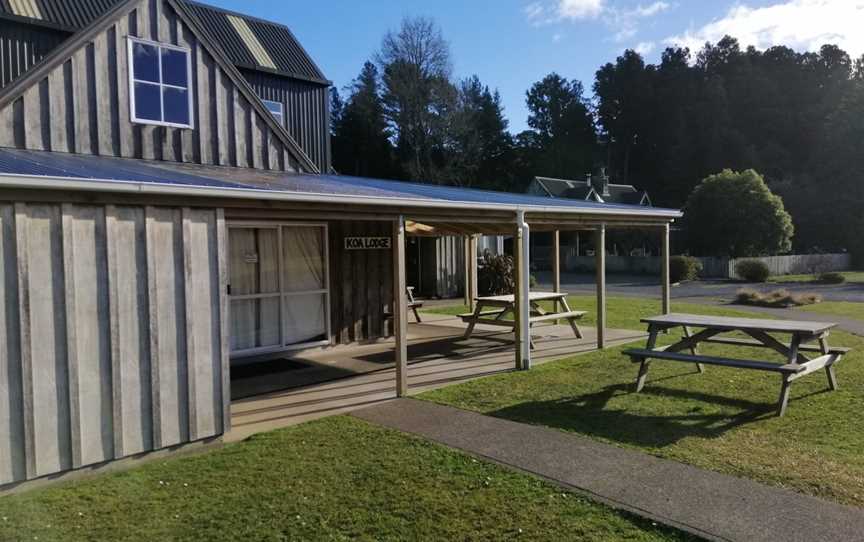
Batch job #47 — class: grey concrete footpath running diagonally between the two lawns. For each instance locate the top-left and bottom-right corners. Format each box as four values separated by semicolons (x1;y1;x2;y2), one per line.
353;399;864;542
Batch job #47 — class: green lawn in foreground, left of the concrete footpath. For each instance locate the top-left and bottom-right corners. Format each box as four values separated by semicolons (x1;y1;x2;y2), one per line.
0;416;689;541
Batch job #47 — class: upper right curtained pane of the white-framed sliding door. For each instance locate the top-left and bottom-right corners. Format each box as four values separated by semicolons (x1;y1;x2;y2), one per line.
282;226;325;292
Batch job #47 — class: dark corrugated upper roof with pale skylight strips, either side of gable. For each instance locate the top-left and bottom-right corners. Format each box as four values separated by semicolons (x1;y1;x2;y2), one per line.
0;0;329;84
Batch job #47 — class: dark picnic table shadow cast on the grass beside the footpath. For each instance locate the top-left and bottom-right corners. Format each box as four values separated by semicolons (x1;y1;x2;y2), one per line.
489;377;776;448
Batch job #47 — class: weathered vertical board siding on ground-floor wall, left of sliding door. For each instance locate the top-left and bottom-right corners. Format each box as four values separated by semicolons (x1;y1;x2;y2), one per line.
0;203;229;485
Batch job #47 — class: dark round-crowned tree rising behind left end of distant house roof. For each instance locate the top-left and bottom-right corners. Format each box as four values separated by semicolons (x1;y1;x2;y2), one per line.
526;73;597;179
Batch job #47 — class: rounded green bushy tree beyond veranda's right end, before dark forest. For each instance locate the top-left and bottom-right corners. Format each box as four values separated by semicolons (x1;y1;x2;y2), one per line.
683;169;794;258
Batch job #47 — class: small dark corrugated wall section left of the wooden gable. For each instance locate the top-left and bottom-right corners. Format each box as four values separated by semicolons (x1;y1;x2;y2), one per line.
0;19;69;88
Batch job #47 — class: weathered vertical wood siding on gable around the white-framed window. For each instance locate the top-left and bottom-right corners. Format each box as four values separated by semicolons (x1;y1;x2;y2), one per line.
0;0;298;171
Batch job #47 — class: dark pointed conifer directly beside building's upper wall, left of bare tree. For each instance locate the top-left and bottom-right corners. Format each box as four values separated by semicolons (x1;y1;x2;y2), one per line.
331;62;399;178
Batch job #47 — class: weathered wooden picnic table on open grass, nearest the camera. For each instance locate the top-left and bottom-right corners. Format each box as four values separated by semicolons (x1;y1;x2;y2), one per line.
624;313;849;416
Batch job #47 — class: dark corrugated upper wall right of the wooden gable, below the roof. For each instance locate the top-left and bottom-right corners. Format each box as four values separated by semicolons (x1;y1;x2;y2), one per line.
241;70;330;172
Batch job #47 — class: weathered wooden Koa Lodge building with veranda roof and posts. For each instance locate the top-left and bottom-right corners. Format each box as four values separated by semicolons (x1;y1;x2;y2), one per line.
0;0;679;487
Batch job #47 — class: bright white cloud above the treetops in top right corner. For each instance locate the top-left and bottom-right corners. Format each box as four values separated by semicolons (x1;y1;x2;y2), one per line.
664;0;864;57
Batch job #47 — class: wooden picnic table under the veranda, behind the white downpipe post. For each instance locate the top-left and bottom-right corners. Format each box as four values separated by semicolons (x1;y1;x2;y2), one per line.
459;292;585;348
